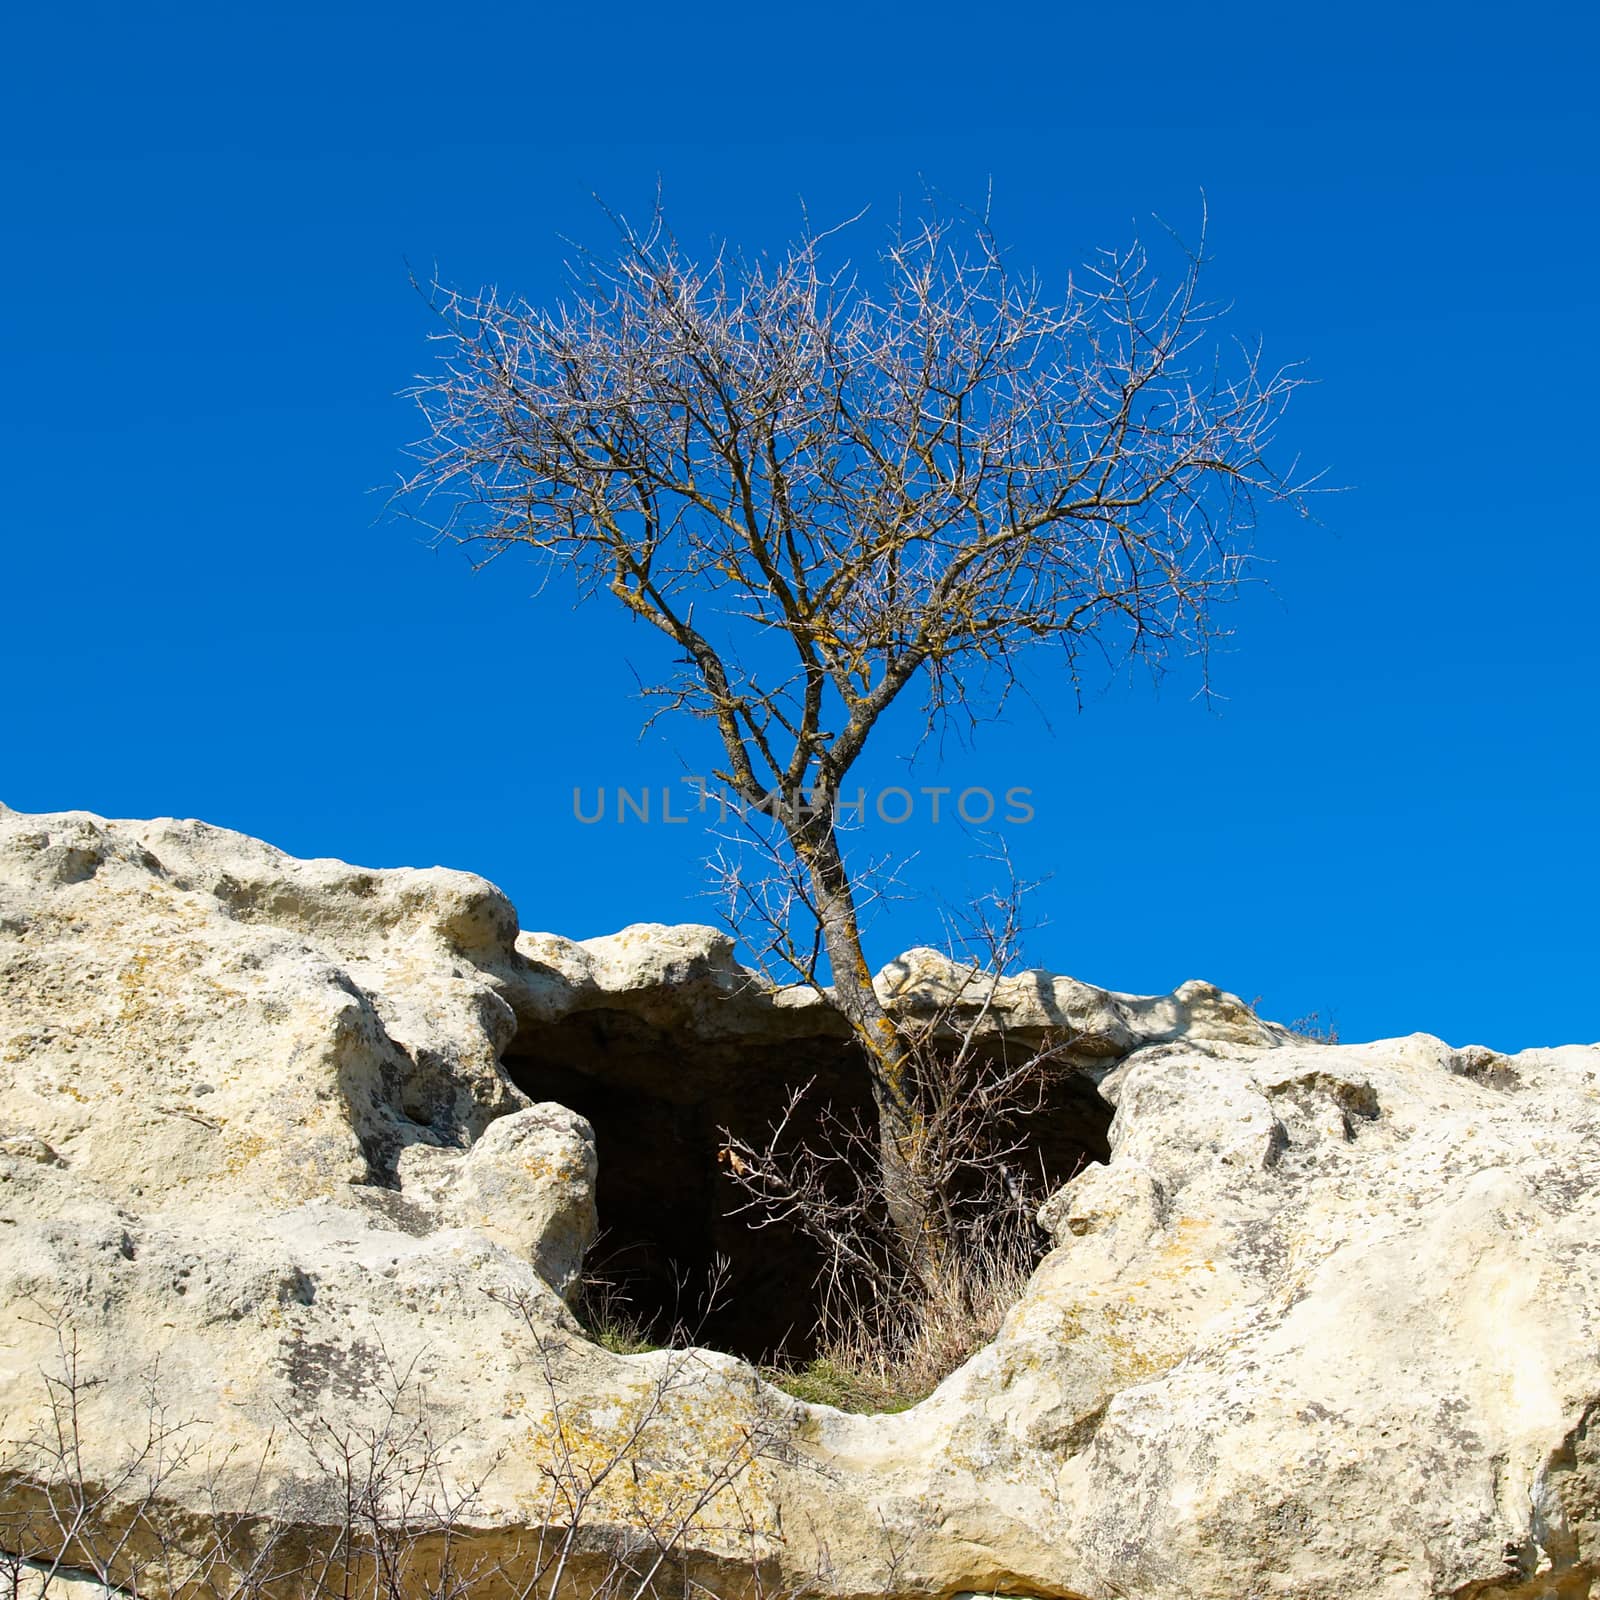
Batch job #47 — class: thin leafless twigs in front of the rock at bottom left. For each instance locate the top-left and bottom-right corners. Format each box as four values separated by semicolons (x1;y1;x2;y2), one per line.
0;1291;793;1600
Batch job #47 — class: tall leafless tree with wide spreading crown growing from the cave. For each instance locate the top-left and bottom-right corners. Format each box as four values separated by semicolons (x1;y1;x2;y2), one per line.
405;203;1302;1273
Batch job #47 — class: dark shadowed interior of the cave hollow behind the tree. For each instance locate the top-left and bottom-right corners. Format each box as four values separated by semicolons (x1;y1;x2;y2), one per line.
504;1010;1112;1362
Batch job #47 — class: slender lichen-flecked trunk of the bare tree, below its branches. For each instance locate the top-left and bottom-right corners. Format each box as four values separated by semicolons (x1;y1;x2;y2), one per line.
789;810;939;1278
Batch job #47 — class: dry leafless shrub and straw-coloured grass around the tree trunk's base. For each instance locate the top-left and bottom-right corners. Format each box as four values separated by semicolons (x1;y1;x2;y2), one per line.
720;878;1082;1410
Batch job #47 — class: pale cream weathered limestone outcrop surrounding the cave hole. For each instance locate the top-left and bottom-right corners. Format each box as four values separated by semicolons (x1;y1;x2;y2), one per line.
0;810;1600;1600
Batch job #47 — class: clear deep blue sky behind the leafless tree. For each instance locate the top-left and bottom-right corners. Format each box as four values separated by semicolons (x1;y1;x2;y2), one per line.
0;0;1600;1048
